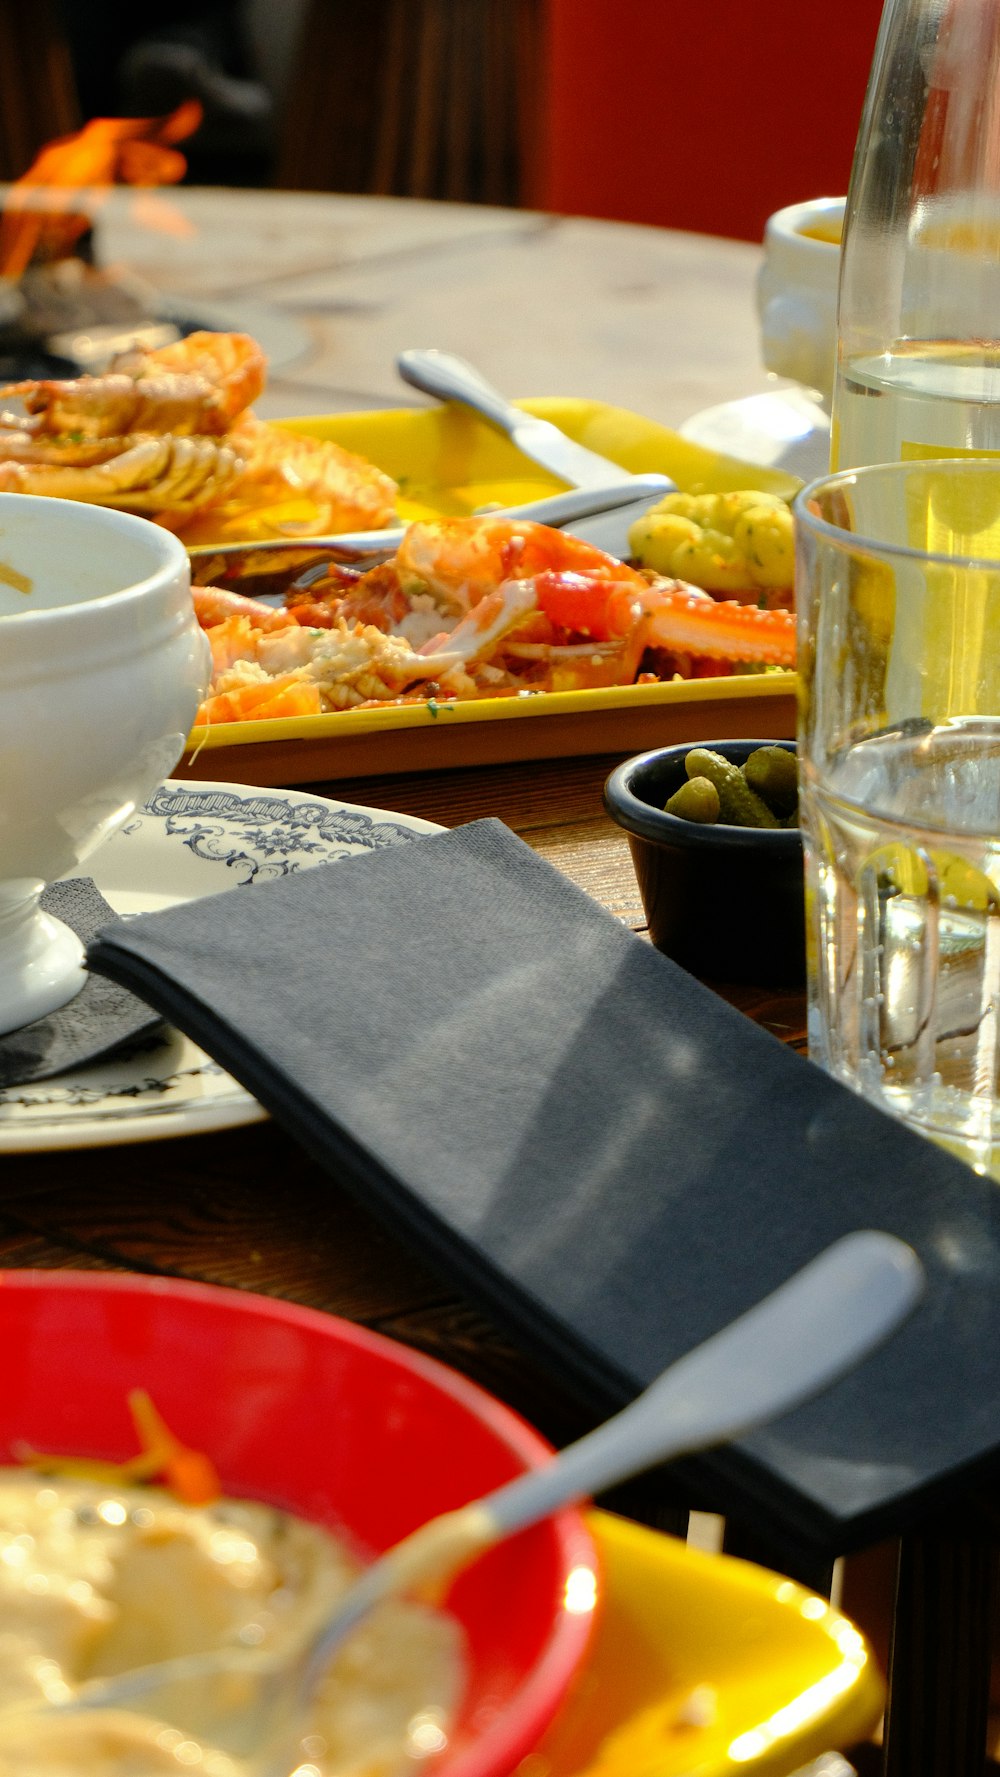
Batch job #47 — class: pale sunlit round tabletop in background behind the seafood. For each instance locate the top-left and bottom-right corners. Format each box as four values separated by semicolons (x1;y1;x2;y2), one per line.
98;188;774;426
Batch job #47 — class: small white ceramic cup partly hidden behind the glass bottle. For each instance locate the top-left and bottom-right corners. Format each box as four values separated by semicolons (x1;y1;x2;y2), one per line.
757;197;845;405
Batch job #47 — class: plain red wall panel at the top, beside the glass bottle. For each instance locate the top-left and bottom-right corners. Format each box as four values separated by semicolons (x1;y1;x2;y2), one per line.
531;0;881;240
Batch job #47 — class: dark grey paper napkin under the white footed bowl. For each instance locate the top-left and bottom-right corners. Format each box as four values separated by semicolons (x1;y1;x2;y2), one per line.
0;876;163;1089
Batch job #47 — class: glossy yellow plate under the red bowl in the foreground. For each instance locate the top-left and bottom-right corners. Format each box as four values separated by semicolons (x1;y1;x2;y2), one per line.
539;1512;885;1777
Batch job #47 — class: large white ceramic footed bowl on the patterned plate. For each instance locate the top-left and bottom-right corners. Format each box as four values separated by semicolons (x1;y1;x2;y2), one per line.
0;494;210;1032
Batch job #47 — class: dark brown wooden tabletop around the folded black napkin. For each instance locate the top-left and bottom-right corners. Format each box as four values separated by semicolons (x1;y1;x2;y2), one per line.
0;757;801;1441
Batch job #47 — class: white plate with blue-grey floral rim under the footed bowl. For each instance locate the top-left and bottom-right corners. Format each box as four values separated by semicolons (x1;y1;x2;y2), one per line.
0;778;440;1153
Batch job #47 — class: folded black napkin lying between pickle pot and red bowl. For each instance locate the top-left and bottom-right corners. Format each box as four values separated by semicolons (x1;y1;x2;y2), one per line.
89;821;1000;1548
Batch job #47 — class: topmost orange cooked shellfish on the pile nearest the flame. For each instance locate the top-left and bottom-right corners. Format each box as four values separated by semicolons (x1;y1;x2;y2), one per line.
0;332;266;439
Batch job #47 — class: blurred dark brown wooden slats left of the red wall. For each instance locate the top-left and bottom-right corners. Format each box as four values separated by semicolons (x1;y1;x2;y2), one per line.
275;0;544;204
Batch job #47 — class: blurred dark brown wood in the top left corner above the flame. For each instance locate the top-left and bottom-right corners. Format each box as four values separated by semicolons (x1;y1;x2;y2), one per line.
0;0;82;181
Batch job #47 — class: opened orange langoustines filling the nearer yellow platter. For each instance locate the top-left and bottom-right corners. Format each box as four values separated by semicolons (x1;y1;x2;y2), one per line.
195;517;796;723
